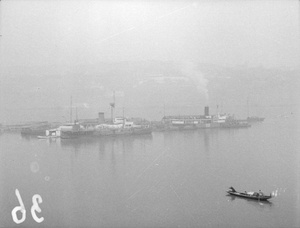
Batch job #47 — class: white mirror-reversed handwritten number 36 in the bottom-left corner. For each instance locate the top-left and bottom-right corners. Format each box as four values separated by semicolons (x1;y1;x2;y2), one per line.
11;189;44;224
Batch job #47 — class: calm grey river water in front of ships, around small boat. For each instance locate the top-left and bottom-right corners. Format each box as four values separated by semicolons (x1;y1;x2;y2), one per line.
0;115;300;227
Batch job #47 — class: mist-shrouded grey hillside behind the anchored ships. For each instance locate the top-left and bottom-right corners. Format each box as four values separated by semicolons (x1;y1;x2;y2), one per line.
0;61;299;122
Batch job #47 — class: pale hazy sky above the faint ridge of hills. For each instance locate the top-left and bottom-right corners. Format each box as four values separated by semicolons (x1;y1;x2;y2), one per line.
1;0;300;67
